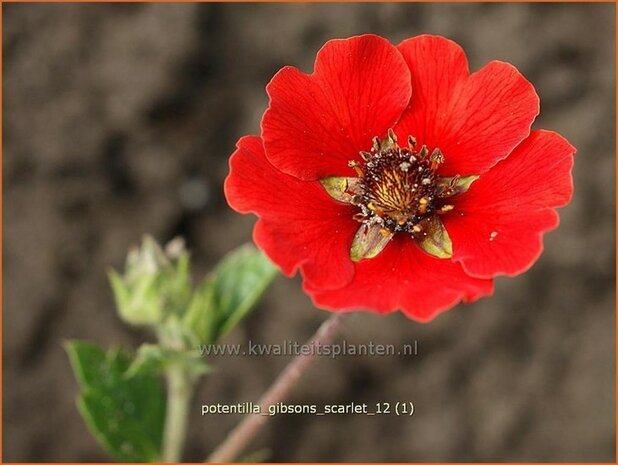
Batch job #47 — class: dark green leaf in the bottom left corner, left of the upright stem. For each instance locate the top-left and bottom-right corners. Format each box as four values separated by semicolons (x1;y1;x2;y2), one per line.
65;341;165;462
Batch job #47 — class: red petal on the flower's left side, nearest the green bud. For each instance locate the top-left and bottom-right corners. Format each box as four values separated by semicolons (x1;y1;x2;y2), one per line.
224;136;358;288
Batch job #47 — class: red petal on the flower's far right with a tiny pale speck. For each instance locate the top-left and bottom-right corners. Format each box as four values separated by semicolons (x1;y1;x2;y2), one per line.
443;131;575;278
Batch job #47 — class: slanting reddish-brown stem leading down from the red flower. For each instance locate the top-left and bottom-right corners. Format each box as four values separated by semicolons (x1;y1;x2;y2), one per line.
208;313;349;463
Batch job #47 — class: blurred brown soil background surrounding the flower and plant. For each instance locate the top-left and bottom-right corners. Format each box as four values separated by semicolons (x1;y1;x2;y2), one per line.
3;3;615;462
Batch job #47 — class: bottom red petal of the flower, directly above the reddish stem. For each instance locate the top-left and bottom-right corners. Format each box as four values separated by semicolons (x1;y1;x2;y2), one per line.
305;234;493;322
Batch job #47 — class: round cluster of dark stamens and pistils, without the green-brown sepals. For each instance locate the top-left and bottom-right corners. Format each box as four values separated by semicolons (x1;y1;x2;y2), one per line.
349;131;453;235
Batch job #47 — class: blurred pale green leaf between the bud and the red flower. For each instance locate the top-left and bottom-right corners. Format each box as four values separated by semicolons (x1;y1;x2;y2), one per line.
184;244;277;344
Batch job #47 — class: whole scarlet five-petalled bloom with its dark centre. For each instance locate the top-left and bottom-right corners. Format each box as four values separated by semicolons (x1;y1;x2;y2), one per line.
225;35;575;321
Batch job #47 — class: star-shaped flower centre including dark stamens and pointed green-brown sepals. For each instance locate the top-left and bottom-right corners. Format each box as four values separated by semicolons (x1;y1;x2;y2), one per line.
320;130;478;262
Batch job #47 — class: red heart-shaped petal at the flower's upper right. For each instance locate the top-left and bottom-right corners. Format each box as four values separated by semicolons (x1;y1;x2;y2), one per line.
396;35;539;176
